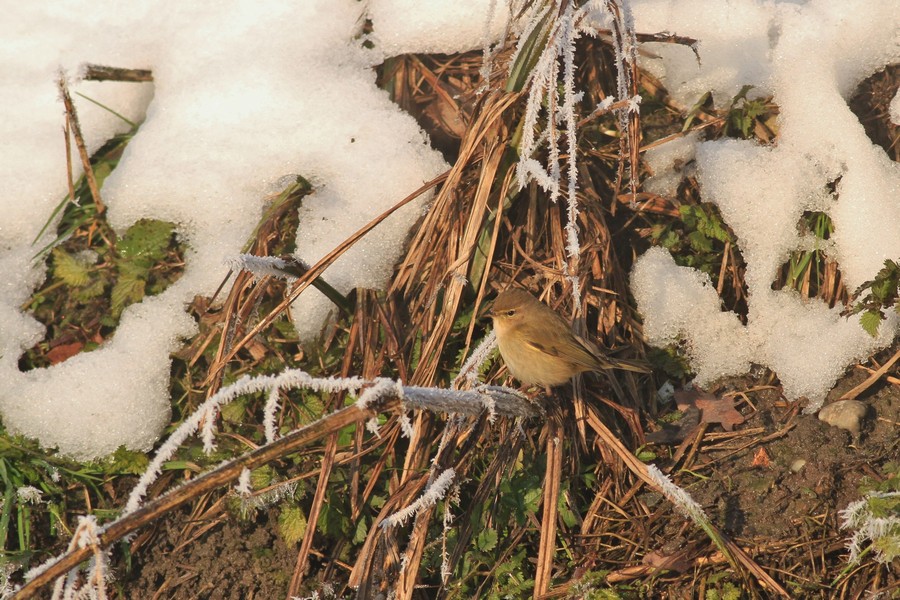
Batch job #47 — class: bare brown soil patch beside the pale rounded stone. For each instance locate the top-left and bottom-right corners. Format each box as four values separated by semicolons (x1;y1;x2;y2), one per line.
688;371;900;540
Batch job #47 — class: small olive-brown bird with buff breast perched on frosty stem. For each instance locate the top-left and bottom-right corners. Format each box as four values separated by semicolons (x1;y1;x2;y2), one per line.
488;289;649;388
